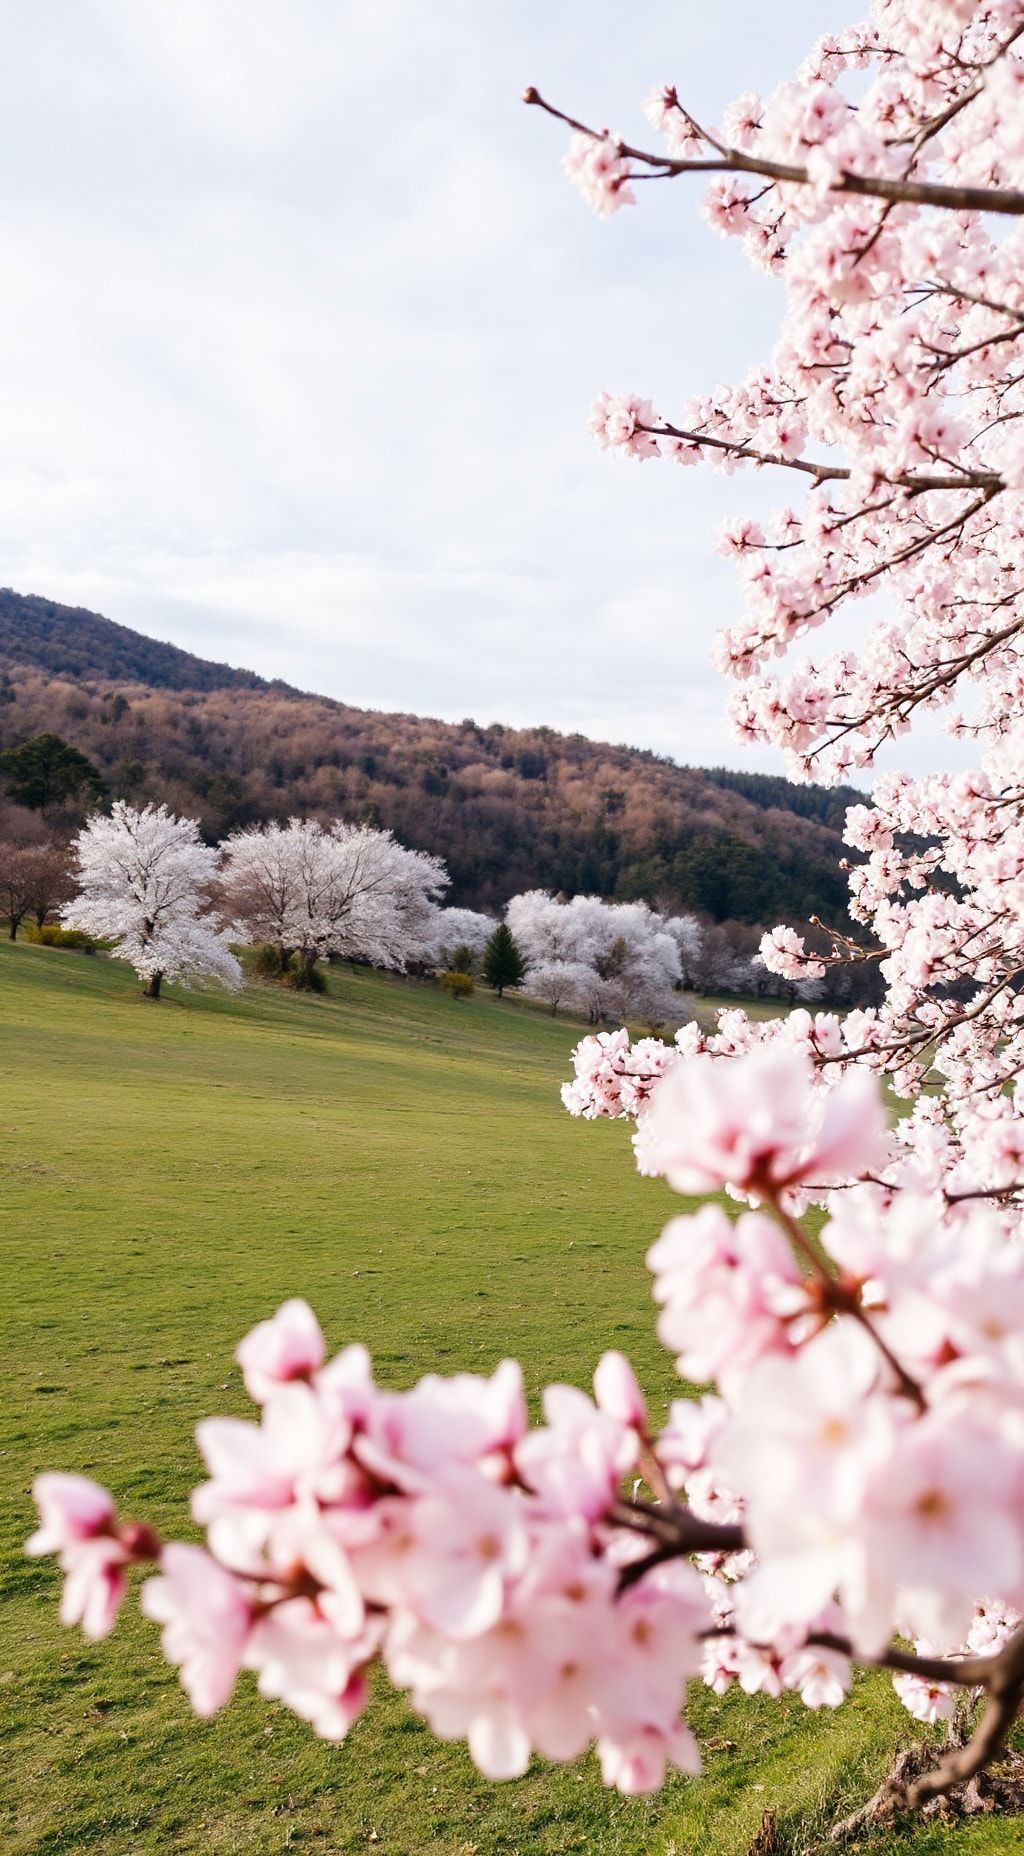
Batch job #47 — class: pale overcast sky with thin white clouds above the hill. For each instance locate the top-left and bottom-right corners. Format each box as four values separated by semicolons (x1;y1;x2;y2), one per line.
0;0;957;783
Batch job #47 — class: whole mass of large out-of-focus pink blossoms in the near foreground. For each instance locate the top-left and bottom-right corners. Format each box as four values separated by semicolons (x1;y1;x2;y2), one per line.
28;1049;1024;1793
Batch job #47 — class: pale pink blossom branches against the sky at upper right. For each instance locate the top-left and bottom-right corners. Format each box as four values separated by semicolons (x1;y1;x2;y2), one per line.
563;0;1024;778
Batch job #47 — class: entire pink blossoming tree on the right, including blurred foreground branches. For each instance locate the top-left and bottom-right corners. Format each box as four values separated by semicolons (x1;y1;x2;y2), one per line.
24;0;1024;1811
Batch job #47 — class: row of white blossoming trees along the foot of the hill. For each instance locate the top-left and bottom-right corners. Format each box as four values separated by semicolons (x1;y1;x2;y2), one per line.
0;801;874;1030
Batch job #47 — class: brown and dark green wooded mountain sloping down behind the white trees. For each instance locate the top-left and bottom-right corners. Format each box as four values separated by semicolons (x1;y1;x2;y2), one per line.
0;590;863;922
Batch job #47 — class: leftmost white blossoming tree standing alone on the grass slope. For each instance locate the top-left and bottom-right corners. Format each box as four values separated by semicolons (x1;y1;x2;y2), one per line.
61;800;241;999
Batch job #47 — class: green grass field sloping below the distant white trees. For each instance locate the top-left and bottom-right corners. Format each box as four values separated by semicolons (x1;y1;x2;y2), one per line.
0;945;1024;1856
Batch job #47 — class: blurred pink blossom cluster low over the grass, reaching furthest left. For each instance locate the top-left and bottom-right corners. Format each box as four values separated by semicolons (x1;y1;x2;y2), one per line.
30;1301;709;1791
